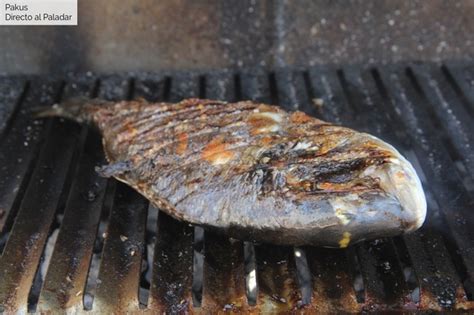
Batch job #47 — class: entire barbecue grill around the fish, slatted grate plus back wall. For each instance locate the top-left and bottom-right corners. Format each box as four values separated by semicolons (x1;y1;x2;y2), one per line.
0;0;474;314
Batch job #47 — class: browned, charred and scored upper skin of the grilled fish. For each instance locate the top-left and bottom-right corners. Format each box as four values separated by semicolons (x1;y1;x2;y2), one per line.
103;101;392;201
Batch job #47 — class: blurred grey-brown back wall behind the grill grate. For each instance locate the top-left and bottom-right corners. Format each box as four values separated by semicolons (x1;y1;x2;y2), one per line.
0;0;474;74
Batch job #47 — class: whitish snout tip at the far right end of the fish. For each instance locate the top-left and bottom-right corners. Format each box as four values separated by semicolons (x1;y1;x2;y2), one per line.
362;135;427;232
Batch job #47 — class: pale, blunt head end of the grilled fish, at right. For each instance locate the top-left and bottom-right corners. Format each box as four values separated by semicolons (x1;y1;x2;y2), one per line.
274;133;426;247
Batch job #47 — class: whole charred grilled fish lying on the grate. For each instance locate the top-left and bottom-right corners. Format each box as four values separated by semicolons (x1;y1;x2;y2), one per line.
37;99;426;248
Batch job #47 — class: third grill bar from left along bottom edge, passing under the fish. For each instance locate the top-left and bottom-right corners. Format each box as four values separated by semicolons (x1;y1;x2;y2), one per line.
94;76;148;313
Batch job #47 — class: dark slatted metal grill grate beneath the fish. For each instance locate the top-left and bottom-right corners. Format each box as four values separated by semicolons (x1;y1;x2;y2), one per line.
0;64;474;313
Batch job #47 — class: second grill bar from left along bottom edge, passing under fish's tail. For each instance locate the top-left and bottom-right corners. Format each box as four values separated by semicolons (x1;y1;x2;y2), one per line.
38;79;106;312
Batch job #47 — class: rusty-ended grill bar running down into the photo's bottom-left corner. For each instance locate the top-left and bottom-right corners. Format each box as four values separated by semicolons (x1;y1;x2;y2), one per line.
0;81;80;312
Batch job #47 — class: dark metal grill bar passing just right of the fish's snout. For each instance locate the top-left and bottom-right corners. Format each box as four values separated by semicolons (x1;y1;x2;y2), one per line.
381;72;474;294
